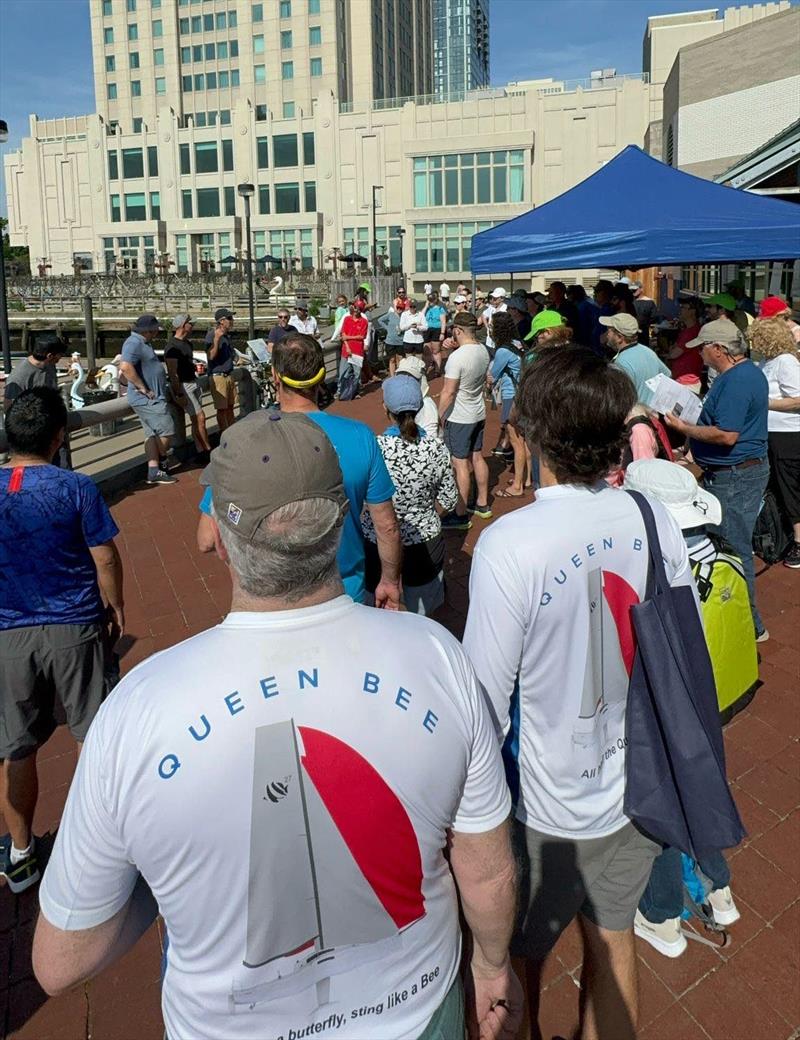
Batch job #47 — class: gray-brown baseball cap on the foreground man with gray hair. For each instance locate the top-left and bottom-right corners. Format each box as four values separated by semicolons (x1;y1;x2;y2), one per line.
204;409;349;542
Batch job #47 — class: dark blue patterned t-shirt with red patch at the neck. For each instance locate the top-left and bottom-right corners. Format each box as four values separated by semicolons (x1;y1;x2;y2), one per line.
0;466;119;630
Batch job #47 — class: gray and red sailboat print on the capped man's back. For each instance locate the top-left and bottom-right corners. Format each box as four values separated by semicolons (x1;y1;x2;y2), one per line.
243;720;425;996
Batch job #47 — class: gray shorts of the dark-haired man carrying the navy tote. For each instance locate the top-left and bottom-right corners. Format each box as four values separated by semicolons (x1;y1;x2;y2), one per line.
511;821;662;961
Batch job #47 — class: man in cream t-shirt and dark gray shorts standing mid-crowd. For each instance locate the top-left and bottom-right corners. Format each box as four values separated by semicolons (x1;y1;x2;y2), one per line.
439;311;492;530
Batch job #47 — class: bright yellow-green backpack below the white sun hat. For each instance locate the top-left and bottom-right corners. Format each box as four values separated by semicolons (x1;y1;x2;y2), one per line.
692;542;760;726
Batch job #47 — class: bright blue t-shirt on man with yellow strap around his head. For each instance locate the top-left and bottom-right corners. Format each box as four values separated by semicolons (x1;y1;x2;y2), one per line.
200;412;394;603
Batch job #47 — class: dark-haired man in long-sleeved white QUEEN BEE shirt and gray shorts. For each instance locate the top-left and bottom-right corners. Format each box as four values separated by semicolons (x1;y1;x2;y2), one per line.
464;347;700;1038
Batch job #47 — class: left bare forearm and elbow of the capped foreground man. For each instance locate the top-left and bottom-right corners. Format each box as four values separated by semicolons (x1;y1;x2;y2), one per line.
33;878;158;996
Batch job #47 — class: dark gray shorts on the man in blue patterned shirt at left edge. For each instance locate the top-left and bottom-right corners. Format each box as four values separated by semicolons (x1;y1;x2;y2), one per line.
0;624;106;758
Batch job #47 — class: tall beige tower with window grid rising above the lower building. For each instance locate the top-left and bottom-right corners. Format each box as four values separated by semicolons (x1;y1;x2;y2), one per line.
91;0;433;133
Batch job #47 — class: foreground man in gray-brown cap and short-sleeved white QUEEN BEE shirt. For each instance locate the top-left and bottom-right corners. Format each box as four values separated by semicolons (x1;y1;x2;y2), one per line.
33;412;521;1040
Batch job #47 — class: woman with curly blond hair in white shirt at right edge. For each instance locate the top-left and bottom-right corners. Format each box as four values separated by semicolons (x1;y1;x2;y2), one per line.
748;317;800;570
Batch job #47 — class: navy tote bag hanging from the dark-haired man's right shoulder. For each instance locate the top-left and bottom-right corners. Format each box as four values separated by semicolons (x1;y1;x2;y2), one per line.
623;491;745;859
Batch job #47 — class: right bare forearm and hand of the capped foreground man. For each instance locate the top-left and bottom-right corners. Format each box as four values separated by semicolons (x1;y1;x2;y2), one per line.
449;821;523;1040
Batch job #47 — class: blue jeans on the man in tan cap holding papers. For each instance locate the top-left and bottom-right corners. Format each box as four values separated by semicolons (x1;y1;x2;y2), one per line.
703;459;770;634
